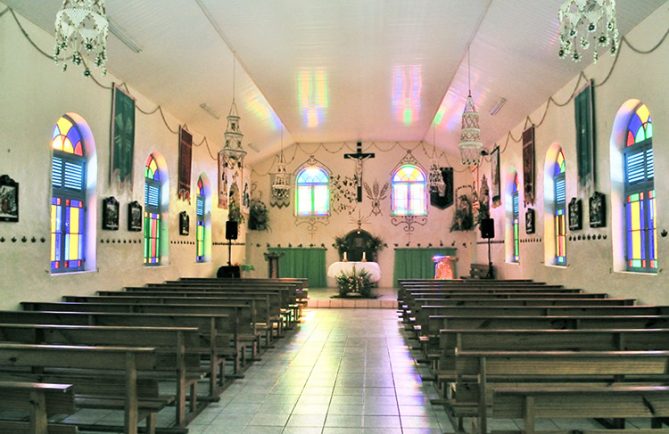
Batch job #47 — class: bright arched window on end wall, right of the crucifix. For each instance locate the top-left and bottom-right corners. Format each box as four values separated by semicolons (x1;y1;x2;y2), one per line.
391;164;427;216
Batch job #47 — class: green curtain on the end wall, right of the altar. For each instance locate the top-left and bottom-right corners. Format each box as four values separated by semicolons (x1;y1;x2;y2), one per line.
393;247;457;286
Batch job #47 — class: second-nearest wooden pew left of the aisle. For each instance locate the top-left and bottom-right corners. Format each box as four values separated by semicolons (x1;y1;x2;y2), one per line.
0;343;159;434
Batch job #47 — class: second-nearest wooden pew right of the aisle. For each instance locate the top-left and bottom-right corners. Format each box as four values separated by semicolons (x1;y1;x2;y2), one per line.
448;351;669;433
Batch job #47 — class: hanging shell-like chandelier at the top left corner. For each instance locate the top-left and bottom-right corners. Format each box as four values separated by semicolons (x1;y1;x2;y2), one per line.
53;0;109;76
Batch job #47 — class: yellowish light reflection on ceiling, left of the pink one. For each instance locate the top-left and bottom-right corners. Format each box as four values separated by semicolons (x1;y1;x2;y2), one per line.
297;68;330;128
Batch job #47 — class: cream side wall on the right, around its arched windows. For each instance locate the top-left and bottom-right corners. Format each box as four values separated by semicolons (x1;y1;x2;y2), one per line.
478;5;669;303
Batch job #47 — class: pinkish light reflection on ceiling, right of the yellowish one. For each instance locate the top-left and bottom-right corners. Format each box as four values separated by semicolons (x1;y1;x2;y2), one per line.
392;65;422;127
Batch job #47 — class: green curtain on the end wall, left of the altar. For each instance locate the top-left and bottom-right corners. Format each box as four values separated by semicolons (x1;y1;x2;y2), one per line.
269;247;327;288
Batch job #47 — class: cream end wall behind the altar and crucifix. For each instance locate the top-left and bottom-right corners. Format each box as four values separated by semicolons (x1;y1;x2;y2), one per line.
247;143;474;287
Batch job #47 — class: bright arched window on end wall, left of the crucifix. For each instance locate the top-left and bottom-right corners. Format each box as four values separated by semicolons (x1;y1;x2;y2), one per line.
295;166;330;217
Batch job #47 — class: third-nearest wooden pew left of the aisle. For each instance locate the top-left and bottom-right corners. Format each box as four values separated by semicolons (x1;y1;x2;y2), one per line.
0;323;204;427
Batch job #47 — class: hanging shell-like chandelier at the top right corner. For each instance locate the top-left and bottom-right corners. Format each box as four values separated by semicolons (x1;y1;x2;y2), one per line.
558;0;620;63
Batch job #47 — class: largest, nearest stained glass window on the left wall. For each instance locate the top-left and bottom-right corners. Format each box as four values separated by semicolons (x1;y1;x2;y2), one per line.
50;115;86;273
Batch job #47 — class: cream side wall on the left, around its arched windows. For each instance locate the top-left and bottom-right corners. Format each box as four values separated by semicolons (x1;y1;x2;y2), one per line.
0;10;244;309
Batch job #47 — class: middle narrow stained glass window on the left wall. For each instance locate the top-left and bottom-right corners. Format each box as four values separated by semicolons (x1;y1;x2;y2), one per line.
144;154;162;265
